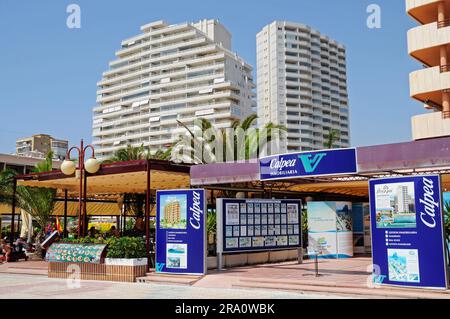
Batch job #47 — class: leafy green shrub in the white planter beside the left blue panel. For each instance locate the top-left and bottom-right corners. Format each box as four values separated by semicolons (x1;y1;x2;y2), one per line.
106;237;147;258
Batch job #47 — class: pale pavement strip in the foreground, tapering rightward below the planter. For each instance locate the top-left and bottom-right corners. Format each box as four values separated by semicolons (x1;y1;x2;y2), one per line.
0;273;340;299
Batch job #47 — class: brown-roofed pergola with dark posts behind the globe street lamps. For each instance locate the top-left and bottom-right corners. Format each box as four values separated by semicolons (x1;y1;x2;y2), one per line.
11;160;191;266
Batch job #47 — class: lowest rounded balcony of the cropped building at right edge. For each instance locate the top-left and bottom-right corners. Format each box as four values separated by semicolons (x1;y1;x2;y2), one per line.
411;112;450;140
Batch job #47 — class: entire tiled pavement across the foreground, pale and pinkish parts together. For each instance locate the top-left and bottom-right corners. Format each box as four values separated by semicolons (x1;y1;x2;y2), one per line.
0;258;450;298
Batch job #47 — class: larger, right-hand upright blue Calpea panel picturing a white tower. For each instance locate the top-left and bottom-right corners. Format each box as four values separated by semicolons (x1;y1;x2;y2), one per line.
369;175;447;289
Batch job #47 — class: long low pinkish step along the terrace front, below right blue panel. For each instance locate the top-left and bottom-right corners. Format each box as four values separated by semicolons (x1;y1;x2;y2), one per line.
233;279;450;299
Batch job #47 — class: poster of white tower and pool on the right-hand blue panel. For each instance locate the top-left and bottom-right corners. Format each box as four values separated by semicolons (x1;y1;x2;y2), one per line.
375;183;416;228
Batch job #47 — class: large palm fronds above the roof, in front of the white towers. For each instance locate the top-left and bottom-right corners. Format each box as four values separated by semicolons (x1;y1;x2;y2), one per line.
171;114;286;164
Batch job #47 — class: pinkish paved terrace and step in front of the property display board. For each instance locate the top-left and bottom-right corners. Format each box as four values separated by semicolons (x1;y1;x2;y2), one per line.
194;258;450;299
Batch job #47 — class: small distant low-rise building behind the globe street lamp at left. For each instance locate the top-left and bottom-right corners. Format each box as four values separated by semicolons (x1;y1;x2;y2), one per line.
16;134;69;161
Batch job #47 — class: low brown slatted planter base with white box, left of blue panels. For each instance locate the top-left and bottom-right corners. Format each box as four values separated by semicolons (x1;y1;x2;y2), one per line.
48;259;147;282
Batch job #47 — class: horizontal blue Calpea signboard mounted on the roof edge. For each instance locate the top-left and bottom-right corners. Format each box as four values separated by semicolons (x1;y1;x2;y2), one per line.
259;148;358;180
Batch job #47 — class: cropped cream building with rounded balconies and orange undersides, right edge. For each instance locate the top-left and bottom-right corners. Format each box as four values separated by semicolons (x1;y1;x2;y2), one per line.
406;0;450;140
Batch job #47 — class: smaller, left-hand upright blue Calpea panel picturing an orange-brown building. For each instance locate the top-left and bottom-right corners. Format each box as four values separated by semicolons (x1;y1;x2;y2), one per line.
156;189;207;274
